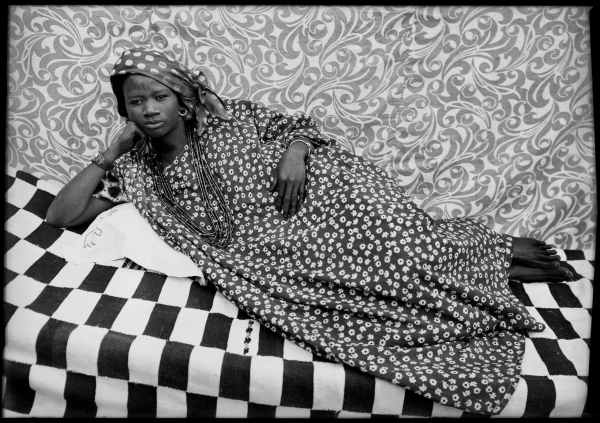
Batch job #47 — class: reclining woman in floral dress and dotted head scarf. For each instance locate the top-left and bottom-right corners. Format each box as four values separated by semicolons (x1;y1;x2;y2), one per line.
47;48;572;414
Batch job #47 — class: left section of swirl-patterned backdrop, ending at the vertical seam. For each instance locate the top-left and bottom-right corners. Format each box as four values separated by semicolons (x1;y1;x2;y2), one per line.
8;6;412;179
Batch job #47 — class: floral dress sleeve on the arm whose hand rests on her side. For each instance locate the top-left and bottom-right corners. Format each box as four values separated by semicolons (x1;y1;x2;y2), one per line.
240;100;335;148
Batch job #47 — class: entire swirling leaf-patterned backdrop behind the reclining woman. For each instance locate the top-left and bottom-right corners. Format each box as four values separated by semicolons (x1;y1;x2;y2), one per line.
6;6;597;249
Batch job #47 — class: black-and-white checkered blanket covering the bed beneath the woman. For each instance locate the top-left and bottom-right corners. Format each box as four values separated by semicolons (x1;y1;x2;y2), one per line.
3;170;594;417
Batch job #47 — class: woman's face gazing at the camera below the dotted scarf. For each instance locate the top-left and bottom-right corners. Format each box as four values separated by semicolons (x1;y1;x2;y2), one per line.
123;75;184;138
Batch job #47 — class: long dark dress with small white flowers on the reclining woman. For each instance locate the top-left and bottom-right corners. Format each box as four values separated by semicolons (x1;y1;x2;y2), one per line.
94;100;543;414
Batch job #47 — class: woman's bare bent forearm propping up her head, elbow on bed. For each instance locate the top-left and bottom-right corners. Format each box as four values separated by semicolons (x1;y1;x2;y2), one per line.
46;147;119;227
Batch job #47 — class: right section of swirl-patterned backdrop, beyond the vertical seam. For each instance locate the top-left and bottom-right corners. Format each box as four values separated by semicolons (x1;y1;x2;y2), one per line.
394;7;596;249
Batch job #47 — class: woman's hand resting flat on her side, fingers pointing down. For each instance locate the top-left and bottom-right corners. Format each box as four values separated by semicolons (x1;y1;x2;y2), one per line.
269;142;308;219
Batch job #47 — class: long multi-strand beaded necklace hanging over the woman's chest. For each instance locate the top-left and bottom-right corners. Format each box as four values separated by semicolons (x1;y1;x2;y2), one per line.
143;128;235;248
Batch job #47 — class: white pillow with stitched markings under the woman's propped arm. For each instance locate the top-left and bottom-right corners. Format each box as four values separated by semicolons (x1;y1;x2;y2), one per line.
62;203;206;285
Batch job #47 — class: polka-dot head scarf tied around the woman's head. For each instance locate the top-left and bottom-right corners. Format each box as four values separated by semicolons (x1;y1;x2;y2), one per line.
110;48;229;135
